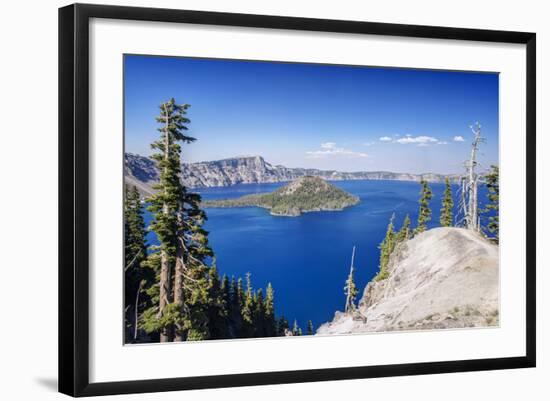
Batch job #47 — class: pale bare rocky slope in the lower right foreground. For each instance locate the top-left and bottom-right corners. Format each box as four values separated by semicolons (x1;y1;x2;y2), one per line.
317;228;499;334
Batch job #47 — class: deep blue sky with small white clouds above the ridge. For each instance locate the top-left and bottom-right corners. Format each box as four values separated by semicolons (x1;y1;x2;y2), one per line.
124;56;498;173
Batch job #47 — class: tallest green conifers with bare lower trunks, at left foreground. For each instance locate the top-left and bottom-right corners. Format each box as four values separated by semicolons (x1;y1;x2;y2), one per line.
146;99;217;342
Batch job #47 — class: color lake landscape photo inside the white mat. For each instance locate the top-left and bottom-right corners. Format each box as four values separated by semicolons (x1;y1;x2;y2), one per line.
121;55;499;344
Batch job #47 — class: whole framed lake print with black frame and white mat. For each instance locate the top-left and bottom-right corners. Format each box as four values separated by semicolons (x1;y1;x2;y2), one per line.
59;4;536;396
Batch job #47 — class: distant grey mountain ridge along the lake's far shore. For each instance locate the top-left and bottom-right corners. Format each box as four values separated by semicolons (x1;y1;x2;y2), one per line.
124;153;466;195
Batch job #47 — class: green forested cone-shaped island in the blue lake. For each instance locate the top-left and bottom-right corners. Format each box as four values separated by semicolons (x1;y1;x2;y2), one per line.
202;176;359;217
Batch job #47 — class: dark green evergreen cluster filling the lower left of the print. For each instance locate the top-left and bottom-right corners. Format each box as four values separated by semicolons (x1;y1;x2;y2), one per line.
124;99;313;342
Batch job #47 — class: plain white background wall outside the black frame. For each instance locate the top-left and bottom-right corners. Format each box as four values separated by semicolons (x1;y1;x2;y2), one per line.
0;0;550;400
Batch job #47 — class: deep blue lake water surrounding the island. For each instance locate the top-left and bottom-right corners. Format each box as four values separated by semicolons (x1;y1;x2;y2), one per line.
146;180;492;329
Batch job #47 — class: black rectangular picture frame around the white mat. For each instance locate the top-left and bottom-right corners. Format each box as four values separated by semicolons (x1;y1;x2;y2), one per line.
59;4;536;397
